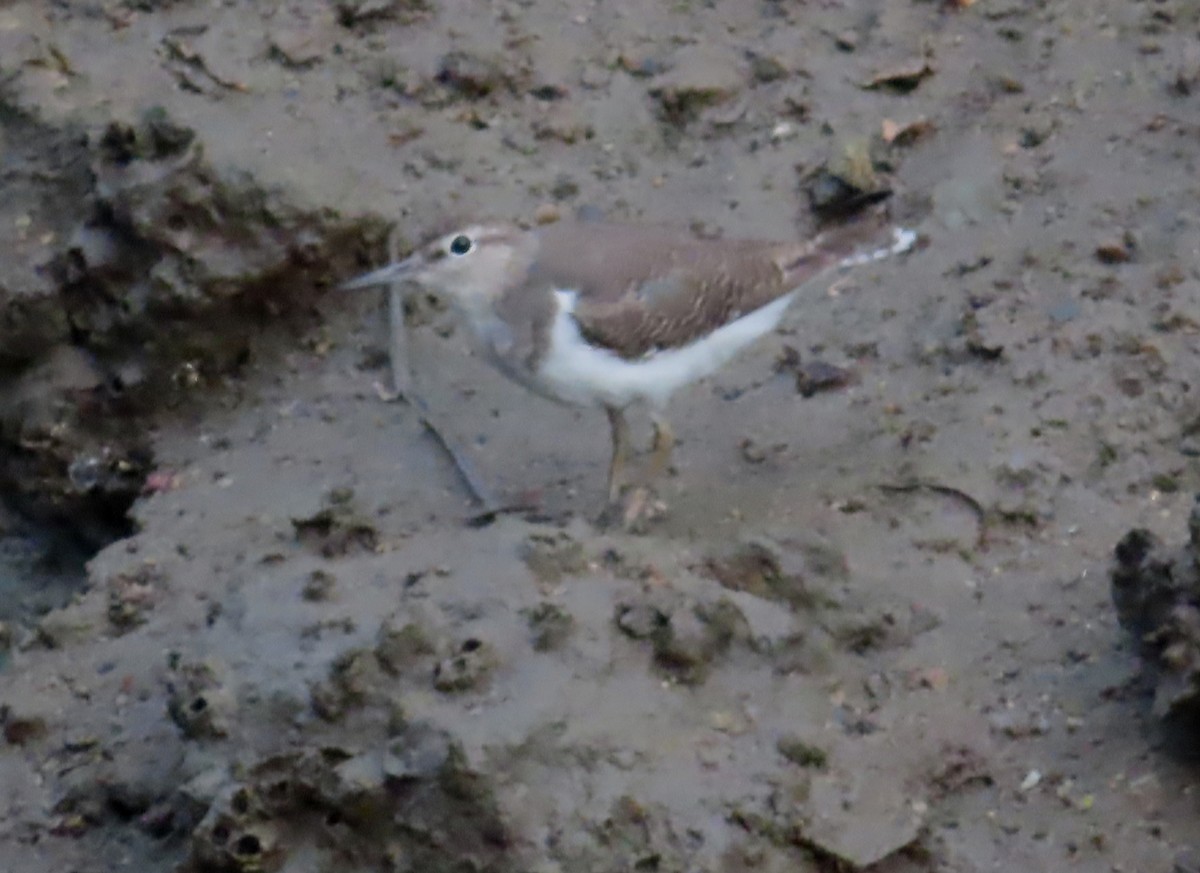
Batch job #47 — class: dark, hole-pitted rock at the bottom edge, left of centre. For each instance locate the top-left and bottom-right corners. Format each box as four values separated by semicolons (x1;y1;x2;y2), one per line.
181;724;511;873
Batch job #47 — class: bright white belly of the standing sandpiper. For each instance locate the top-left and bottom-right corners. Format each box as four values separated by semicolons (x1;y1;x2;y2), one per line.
532;291;792;409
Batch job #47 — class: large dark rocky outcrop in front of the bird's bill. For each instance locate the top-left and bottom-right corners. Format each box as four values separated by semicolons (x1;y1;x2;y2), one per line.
0;102;384;541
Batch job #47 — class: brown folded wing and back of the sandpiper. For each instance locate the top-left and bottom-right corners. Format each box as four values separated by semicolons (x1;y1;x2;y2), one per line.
536;224;897;359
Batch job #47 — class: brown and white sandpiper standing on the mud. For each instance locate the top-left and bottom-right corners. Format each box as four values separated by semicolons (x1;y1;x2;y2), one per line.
341;211;917;505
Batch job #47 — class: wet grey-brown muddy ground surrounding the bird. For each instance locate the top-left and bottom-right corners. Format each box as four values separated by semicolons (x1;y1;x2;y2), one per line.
0;0;1200;873
